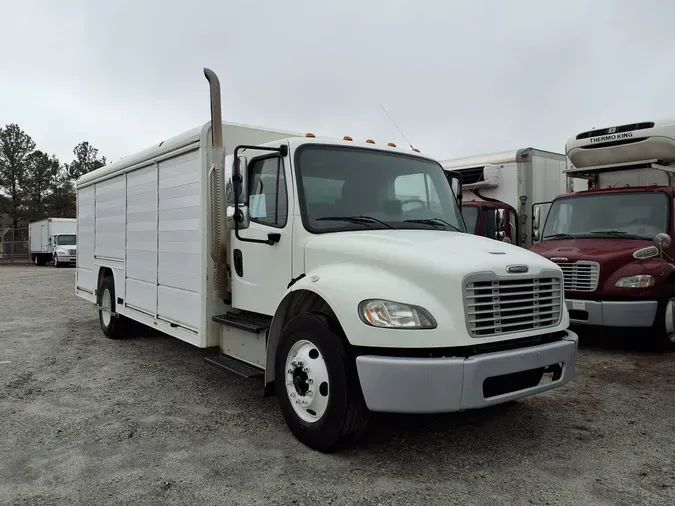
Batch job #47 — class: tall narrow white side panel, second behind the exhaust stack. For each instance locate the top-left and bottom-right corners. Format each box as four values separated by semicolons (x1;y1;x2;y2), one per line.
126;164;157;316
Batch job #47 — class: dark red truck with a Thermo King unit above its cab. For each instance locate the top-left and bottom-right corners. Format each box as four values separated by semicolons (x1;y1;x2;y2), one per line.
531;121;675;350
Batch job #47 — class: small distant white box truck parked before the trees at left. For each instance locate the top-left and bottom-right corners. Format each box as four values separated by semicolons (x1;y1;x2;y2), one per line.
28;218;77;267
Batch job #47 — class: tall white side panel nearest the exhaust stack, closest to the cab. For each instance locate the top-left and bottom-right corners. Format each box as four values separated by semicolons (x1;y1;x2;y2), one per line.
157;150;204;332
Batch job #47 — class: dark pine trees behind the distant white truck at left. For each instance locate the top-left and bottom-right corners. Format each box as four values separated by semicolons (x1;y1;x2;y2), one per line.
0;123;106;228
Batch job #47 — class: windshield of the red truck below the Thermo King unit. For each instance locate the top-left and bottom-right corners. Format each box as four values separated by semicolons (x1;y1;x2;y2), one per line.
542;192;668;240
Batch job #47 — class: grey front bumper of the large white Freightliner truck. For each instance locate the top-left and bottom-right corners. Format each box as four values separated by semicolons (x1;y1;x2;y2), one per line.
356;330;579;413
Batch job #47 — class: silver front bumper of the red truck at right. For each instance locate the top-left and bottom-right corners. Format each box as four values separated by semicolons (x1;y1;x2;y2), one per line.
565;299;658;327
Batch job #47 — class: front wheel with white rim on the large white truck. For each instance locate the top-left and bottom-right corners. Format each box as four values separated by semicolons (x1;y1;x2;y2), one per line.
275;313;369;453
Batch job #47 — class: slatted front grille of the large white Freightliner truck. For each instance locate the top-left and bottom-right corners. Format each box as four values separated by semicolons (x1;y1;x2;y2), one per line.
464;276;563;337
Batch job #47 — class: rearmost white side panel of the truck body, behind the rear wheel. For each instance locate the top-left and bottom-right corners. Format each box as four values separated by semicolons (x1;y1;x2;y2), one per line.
77;186;96;293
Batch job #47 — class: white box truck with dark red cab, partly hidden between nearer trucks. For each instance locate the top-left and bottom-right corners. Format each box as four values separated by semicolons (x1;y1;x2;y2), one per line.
441;148;575;248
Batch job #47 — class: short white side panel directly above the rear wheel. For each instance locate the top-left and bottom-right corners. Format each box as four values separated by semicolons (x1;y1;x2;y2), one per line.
94;174;126;260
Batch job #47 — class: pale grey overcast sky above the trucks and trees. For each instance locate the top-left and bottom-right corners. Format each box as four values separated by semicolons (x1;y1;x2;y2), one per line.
0;0;675;161
